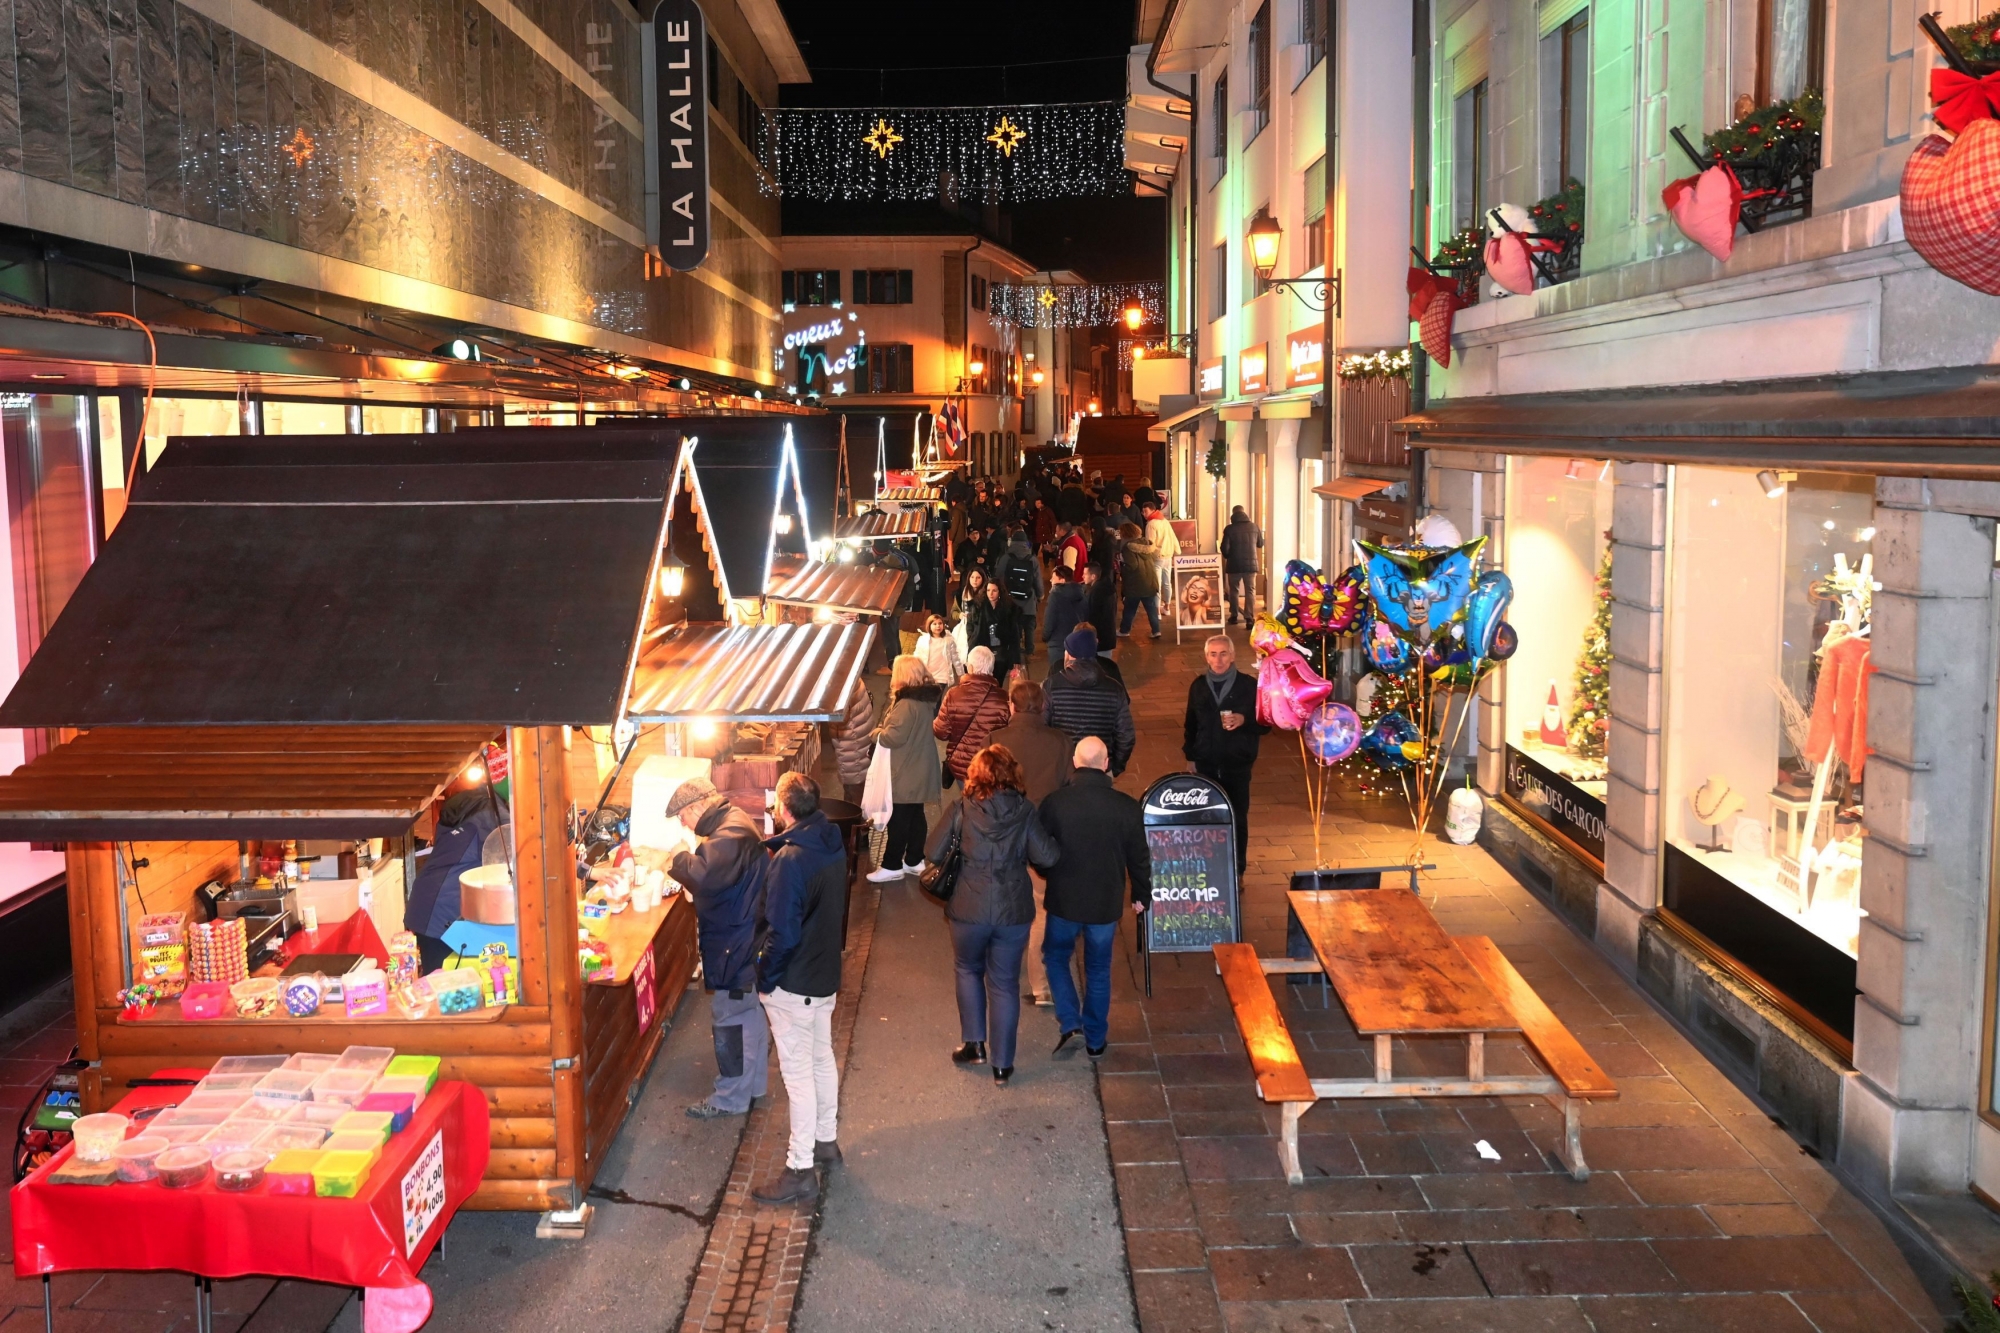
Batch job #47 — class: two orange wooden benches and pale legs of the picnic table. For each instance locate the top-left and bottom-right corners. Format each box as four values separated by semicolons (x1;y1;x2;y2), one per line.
1214;935;1618;1185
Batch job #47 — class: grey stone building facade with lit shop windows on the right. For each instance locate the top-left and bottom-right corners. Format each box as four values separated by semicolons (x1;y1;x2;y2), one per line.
1404;0;2000;1273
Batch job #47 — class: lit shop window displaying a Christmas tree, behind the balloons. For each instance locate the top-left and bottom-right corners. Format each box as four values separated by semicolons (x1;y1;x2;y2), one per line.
1492;456;1612;867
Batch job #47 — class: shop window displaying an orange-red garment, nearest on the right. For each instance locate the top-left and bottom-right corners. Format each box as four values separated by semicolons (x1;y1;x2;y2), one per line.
1656;468;1874;1043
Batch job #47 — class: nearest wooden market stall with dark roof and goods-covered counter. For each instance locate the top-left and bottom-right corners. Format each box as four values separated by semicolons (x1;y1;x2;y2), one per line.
0;430;868;1213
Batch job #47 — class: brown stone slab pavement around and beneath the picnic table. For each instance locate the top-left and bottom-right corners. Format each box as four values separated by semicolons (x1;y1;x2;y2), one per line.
1100;624;1944;1333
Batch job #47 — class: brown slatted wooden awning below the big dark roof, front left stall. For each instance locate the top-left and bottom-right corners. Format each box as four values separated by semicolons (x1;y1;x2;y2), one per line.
0;727;494;843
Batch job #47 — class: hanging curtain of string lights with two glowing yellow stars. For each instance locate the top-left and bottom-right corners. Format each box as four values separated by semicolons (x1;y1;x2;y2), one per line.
758;102;1132;204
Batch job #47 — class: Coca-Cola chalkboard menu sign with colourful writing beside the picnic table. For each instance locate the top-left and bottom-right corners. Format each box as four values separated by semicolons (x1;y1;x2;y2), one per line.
1144;773;1242;953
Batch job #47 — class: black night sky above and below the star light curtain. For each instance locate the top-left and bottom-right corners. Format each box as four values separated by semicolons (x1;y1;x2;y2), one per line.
778;0;1166;280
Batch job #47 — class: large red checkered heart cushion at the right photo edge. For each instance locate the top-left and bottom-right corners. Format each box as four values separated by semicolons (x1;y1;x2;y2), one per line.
1902;120;2000;296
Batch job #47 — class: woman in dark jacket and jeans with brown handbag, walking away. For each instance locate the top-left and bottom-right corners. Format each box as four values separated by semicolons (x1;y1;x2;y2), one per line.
924;745;1062;1083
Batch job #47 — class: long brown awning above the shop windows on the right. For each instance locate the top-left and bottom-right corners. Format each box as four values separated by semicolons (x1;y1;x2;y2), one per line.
1394;366;2000;480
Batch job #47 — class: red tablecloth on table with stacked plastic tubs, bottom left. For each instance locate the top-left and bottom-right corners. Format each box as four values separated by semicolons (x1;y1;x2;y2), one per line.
10;1083;490;1329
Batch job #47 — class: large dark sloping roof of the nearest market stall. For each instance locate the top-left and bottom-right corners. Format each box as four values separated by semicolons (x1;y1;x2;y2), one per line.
0;430;678;729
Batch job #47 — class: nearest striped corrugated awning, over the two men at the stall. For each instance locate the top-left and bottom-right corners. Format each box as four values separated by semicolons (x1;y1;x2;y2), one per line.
626;622;876;723
